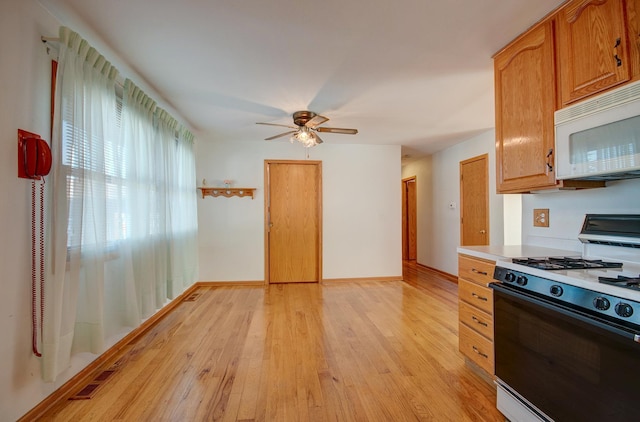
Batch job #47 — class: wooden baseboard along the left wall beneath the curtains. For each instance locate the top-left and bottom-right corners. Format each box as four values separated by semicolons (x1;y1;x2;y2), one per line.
18;283;199;421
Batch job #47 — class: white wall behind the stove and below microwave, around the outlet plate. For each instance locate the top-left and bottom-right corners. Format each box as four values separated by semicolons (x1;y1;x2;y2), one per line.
522;179;640;251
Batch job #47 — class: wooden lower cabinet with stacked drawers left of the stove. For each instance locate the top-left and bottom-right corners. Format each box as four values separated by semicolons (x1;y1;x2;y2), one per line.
458;254;495;378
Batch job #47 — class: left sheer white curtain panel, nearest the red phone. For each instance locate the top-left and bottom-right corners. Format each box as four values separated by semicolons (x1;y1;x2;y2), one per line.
42;28;117;381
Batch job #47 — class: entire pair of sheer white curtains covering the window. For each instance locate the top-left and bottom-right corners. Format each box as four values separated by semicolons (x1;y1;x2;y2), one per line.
43;28;197;381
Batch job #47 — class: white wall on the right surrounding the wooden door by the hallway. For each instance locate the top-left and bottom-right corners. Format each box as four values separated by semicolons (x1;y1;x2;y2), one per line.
402;130;504;274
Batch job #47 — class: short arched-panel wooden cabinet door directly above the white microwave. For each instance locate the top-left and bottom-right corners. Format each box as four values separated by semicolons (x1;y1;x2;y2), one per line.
557;0;631;105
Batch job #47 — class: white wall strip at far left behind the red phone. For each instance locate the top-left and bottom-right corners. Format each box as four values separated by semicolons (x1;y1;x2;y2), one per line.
0;0;58;421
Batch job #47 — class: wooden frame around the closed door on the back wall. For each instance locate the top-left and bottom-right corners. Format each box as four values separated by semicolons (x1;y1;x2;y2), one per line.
264;159;322;285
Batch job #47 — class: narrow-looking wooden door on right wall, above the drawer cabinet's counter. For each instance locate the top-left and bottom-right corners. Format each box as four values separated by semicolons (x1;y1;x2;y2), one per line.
460;154;489;246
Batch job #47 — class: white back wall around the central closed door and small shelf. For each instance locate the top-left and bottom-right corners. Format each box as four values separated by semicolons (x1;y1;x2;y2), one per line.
196;139;402;281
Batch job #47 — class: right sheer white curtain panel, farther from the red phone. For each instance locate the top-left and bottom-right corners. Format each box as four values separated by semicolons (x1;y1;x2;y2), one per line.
122;80;198;317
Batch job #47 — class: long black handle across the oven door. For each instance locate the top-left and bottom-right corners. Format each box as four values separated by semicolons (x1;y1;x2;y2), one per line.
489;283;640;343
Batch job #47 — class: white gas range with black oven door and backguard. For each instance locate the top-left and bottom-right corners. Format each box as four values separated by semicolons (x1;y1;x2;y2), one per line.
492;215;640;422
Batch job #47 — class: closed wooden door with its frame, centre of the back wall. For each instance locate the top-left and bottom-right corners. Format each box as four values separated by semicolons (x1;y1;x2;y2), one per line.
265;161;322;283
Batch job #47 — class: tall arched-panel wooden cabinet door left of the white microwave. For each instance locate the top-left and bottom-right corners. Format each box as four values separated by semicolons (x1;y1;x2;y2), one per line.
494;21;556;192
